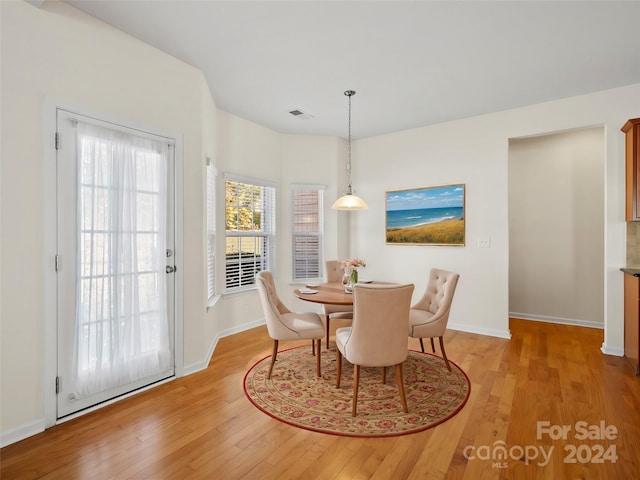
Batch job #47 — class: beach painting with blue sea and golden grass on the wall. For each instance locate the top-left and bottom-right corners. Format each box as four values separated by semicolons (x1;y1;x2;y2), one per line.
385;184;465;246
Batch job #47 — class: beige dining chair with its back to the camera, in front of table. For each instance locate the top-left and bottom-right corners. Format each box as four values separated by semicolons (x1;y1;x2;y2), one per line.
336;284;414;417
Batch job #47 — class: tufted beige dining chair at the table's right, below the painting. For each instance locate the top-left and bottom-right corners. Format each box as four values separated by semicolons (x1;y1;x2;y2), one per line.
409;268;460;371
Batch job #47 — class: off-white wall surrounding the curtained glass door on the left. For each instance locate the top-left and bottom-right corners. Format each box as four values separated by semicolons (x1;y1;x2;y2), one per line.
0;1;215;443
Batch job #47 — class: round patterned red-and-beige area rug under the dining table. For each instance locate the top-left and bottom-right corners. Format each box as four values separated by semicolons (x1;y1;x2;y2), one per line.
244;346;471;437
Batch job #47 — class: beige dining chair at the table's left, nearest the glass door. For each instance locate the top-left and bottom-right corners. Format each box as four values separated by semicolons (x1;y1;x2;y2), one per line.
256;271;324;378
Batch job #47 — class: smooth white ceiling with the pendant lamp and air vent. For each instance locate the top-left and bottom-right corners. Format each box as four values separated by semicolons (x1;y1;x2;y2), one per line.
61;0;640;138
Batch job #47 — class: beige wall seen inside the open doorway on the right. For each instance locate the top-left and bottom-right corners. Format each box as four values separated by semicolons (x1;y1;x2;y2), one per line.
509;127;604;328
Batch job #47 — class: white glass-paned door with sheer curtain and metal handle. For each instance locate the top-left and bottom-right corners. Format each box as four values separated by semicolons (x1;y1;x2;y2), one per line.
56;109;175;418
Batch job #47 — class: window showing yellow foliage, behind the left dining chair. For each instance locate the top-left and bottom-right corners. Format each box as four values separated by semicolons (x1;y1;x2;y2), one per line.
225;177;276;290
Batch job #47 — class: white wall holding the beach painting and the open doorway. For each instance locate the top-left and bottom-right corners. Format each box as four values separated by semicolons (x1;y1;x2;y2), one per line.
351;84;640;346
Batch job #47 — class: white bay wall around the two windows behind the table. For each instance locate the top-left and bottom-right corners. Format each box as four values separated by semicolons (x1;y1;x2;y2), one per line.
212;130;344;326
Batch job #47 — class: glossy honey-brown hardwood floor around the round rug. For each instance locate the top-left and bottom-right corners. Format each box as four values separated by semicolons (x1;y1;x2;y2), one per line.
0;320;640;480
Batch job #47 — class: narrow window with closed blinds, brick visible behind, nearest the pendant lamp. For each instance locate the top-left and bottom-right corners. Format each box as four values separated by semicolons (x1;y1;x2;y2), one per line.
291;185;325;280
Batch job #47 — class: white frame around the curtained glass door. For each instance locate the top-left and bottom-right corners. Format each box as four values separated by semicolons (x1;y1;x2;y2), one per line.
42;97;184;428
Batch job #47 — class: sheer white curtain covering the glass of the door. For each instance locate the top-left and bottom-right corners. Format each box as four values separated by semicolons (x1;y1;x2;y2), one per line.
73;122;173;398
